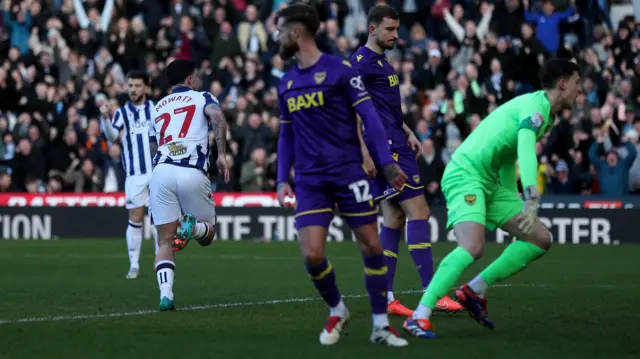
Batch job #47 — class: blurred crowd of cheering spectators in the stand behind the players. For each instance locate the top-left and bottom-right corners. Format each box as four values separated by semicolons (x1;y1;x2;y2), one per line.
0;0;640;204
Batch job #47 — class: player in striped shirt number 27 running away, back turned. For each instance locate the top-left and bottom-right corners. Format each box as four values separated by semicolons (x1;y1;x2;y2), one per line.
149;60;229;311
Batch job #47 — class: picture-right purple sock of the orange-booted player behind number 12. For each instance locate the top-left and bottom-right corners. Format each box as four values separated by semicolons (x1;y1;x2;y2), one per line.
407;220;433;288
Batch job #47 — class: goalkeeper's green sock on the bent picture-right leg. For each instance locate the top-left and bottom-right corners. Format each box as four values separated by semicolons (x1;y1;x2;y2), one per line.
476;240;547;293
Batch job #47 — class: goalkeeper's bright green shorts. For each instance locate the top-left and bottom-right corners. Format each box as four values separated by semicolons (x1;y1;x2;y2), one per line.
441;162;523;231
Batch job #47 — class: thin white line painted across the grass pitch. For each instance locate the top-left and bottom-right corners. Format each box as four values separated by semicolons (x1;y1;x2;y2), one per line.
0;283;618;325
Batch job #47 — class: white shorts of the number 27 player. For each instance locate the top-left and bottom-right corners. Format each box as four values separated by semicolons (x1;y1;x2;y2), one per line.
150;164;216;225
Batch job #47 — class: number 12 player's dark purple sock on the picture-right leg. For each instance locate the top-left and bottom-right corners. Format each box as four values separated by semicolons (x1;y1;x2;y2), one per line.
364;254;387;314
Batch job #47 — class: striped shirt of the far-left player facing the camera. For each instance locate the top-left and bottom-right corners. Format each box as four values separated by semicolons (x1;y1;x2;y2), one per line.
111;100;154;176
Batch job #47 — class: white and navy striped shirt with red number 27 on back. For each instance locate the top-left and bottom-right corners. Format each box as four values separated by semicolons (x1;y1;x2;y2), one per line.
149;86;220;173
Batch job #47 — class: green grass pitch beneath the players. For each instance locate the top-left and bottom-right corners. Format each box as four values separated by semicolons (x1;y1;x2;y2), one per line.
0;239;640;359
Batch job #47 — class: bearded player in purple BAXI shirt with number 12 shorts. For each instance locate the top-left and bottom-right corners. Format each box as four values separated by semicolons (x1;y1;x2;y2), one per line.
277;4;408;347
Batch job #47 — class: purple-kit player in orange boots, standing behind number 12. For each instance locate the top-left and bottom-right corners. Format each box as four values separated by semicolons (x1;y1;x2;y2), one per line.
351;5;462;316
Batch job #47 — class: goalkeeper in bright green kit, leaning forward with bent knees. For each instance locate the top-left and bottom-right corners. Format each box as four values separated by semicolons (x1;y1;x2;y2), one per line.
403;59;580;338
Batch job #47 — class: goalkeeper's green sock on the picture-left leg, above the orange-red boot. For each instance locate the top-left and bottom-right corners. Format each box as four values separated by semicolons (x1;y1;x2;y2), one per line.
413;247;474;319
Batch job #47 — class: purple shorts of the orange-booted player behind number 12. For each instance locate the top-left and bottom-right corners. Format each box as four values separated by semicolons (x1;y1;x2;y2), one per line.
369;146;424;202
